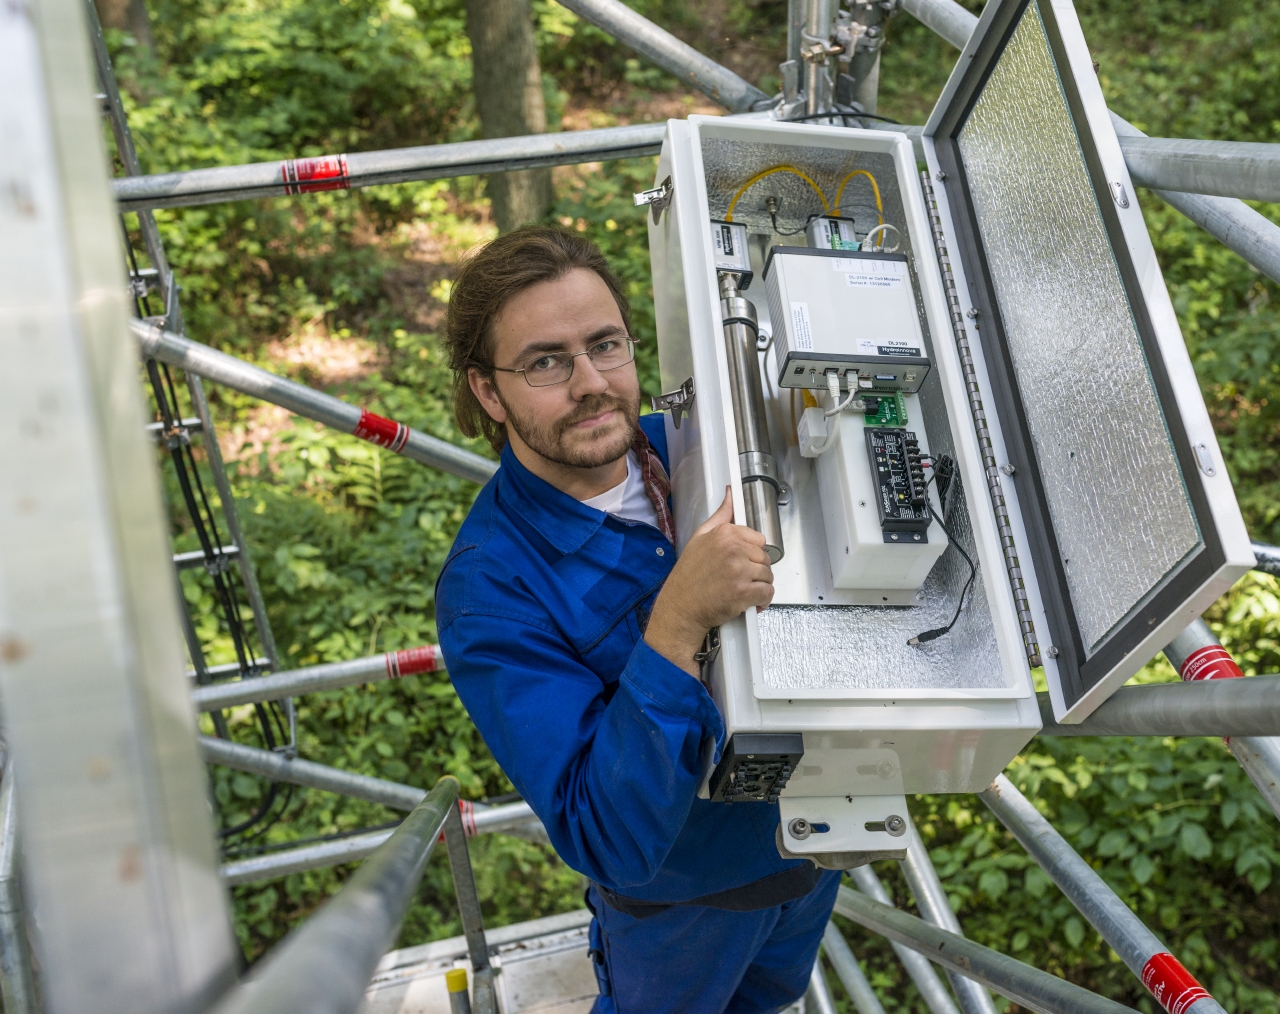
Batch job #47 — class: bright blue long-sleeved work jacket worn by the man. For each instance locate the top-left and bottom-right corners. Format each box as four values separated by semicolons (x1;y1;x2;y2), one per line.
435;414;803;903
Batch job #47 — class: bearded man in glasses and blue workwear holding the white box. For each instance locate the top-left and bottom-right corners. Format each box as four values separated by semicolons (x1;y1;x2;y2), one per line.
436;228;838;1014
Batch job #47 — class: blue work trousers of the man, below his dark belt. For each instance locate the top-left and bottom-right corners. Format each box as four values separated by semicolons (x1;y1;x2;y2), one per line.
588;871;840;1014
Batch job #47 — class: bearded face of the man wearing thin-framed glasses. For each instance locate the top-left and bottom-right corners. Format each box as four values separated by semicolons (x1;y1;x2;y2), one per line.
468;268;640;469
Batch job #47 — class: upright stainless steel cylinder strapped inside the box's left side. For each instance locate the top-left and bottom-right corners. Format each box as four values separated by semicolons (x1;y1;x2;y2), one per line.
721;274;785;563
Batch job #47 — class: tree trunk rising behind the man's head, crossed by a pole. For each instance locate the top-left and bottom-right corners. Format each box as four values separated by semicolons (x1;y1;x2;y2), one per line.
466;0;552;233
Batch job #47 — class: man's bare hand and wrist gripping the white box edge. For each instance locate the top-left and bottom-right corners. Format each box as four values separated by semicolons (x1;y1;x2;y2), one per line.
644;489;773;676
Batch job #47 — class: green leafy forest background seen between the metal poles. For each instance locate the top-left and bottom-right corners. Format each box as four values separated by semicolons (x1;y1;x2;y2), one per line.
100;0;1280;1014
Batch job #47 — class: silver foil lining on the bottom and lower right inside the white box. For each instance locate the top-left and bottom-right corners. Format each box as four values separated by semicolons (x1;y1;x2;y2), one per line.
758;368;1007;691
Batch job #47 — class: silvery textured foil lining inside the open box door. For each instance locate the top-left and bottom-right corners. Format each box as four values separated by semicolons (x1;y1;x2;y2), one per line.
959;4;1201;654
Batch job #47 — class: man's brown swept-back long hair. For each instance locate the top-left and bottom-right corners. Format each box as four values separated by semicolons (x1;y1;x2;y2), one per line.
444;225;631;451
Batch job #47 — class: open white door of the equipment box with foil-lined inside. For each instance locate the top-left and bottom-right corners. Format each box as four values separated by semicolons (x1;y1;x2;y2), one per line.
924;0;1253;722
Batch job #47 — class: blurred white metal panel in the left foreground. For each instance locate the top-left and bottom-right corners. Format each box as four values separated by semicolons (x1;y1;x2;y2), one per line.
0;0;237;1014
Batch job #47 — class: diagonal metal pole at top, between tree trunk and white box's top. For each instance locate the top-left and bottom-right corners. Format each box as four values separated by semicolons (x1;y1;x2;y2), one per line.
552;0;771;113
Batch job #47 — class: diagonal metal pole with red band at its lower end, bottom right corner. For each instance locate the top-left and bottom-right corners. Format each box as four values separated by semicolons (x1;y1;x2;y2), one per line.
980;775;1222;1014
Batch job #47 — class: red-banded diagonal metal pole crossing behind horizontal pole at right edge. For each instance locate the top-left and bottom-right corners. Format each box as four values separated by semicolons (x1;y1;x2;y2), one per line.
1165;620;1280;818
